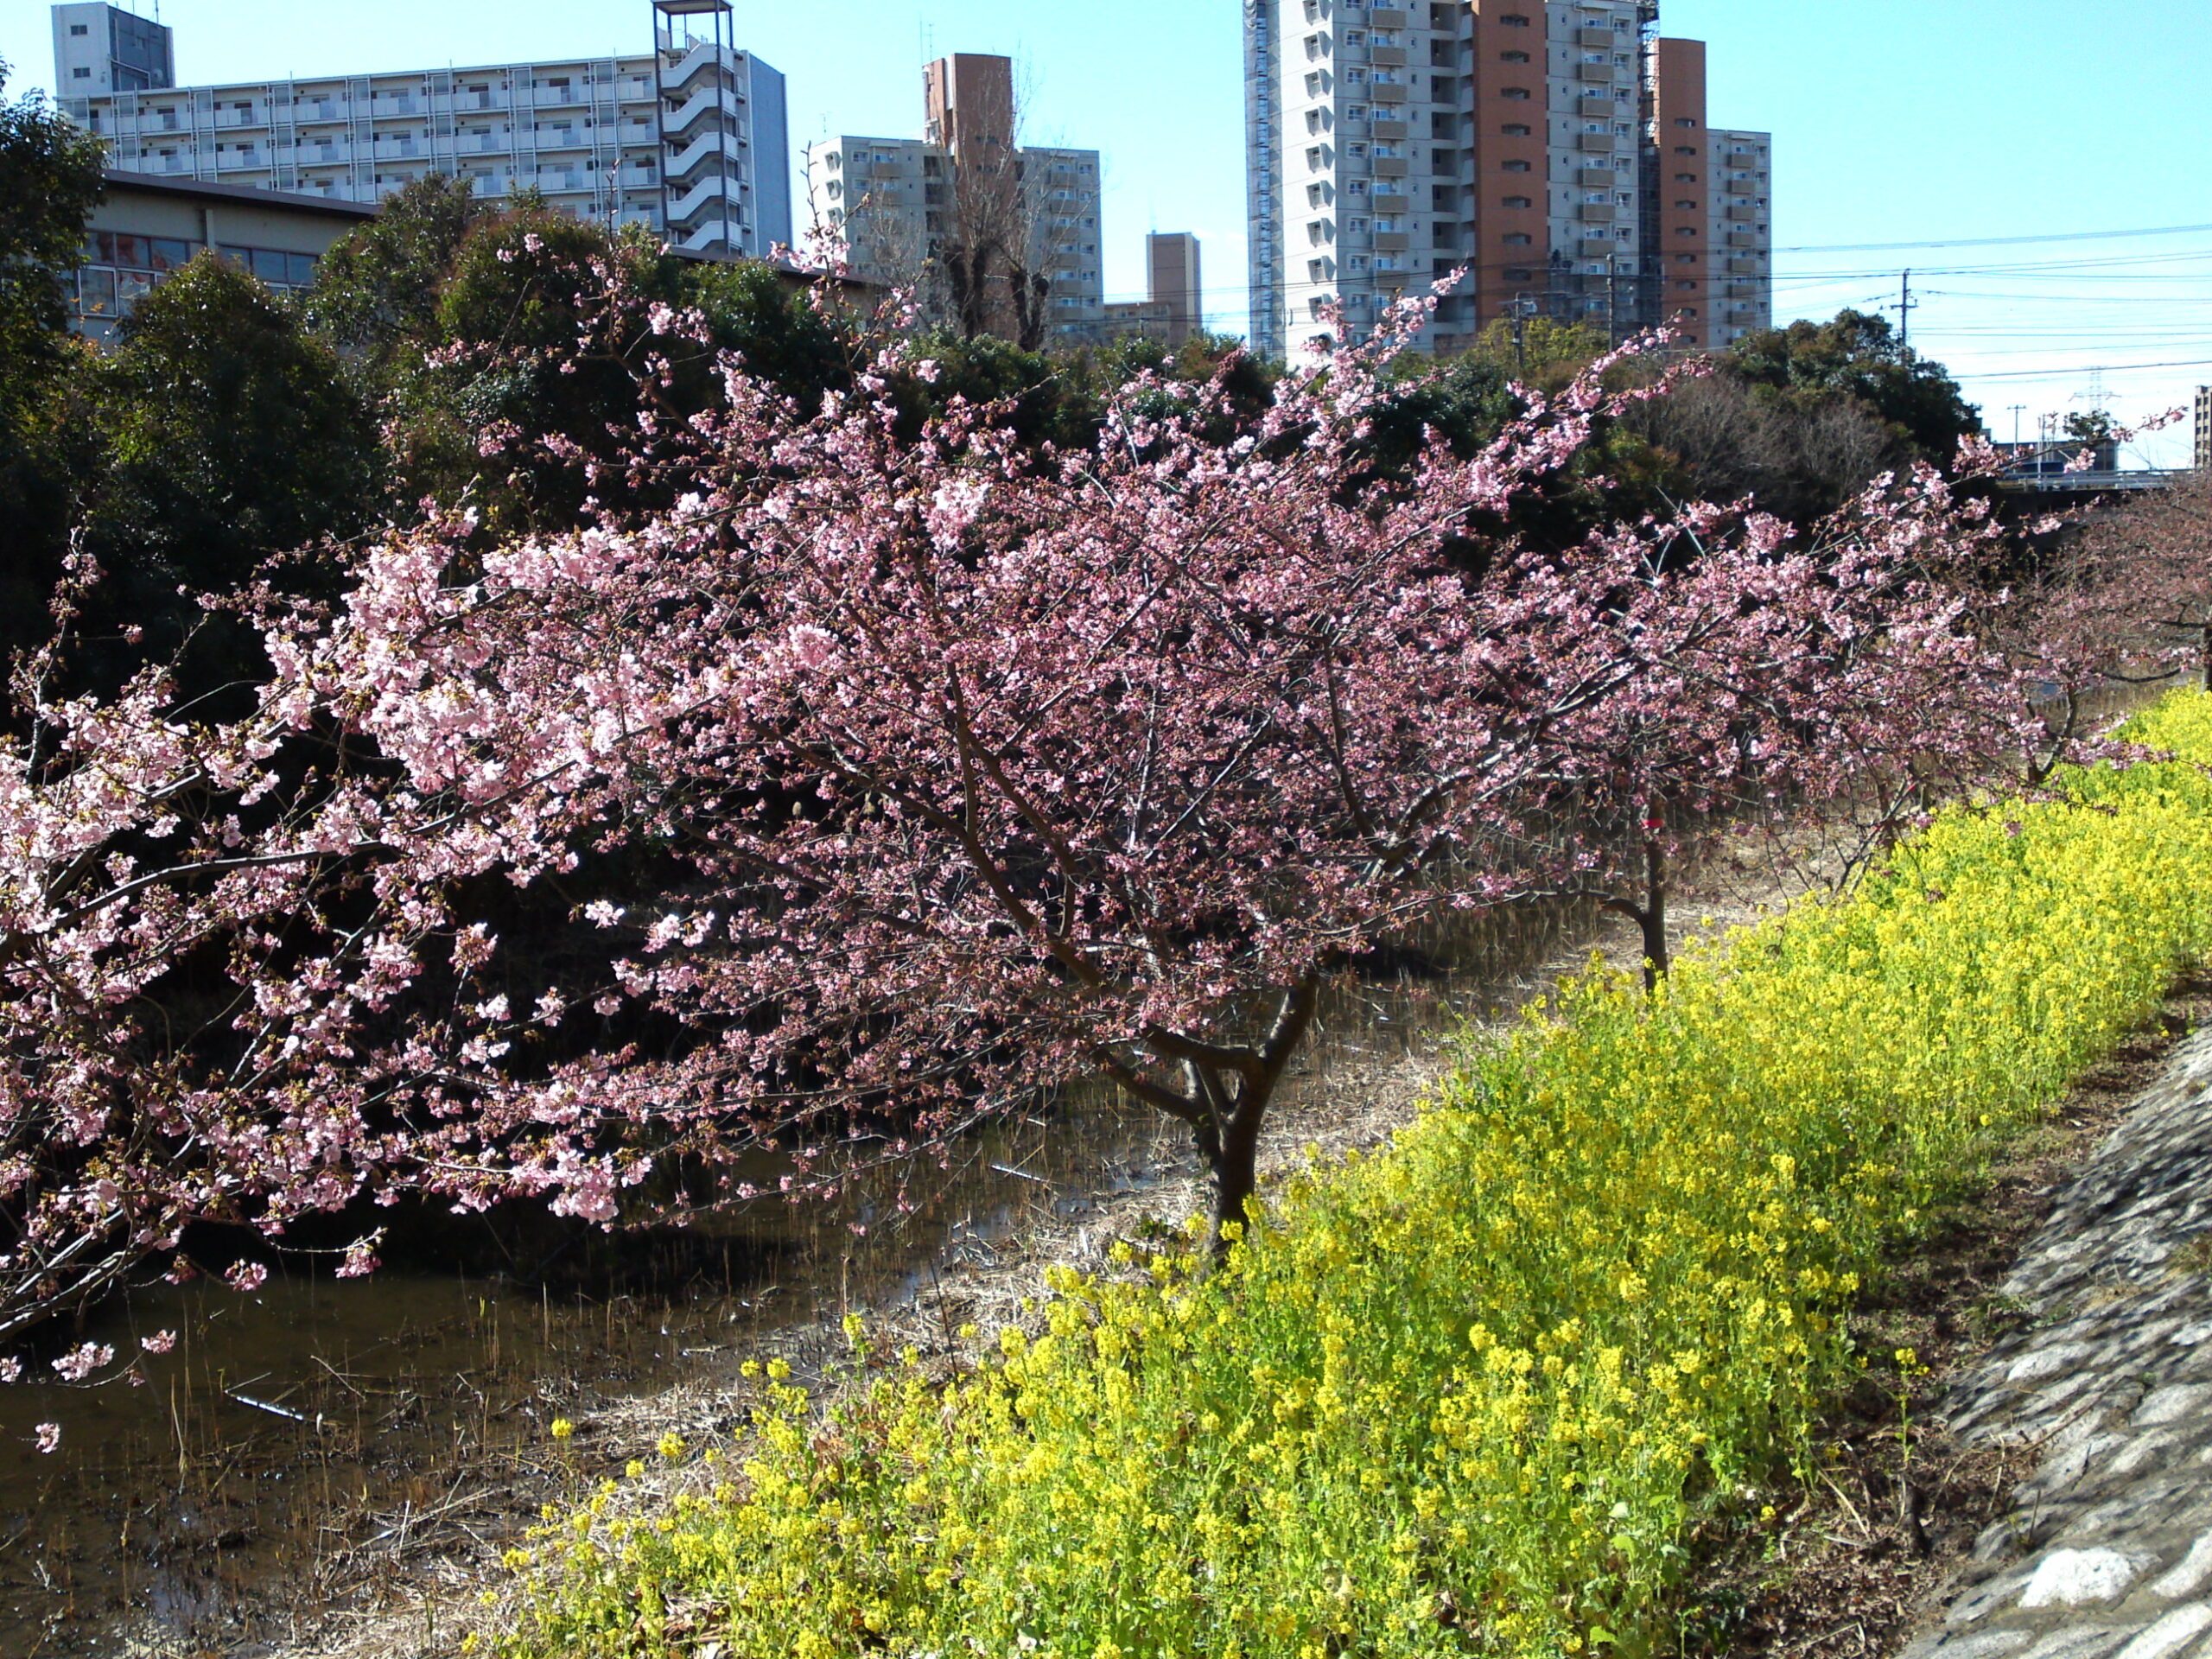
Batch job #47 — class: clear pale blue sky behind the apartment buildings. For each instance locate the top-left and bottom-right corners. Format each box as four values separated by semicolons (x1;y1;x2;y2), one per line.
0;0;2212;460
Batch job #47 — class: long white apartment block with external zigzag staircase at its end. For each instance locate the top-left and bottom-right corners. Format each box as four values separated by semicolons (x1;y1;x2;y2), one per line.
53;0;791;257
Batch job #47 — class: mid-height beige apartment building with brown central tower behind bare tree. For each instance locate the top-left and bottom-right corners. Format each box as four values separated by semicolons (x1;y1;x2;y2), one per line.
807;53;1106;343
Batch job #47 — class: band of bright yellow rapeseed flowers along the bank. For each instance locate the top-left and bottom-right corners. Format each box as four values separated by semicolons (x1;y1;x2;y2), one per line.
493;695;2212;1659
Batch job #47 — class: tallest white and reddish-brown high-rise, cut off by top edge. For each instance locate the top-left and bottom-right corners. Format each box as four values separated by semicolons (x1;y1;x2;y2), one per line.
1243;0;1772;354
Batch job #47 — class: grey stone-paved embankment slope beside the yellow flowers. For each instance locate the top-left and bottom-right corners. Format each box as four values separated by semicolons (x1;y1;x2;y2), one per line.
1904;1027;2212;1659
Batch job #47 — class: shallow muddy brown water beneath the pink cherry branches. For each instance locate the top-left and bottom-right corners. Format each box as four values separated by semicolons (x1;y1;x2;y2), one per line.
0;902;1568;1659
